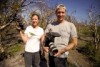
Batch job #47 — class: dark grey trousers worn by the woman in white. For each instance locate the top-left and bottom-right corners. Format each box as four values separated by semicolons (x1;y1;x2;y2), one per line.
24;52;40;67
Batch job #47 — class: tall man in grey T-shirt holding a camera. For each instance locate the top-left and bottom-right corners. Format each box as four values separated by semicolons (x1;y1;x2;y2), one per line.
44;4;77;67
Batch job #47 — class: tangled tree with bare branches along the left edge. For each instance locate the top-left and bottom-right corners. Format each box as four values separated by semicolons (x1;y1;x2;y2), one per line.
0;0;24;59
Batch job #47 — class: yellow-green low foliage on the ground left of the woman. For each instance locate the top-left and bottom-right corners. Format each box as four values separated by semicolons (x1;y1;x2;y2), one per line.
0;43;24;61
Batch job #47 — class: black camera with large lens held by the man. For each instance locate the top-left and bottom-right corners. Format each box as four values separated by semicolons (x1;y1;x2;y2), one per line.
45;32;60;55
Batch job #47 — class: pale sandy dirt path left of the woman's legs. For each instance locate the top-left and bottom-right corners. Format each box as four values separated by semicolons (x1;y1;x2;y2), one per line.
0;51;25;67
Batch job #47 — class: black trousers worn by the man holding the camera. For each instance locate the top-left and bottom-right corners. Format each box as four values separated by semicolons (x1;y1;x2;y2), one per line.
49;55;68;67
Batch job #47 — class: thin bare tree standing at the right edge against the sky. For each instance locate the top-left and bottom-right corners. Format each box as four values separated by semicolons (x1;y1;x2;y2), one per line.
89;6;100;49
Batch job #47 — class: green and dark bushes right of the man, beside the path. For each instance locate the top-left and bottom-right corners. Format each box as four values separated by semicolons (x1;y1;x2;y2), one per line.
77;25;100;67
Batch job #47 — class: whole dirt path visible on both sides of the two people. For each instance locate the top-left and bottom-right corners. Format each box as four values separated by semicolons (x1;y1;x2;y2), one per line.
0;50;92;67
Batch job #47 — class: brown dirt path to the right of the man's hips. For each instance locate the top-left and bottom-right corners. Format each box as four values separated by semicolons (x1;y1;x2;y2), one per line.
68;50;92;67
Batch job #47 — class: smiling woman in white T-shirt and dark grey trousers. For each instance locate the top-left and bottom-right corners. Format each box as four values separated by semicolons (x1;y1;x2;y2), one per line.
20;13;44;67
